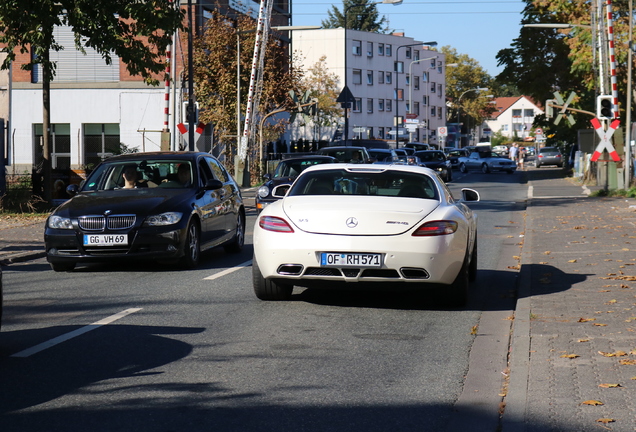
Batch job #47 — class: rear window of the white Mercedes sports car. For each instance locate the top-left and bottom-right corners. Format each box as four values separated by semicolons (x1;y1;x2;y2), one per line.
287;169;439;199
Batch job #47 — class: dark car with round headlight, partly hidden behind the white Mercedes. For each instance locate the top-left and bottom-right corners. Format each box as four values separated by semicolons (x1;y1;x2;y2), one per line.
254;155;338;212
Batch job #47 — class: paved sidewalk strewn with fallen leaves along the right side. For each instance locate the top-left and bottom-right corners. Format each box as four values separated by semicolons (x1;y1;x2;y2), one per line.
503;170;636;432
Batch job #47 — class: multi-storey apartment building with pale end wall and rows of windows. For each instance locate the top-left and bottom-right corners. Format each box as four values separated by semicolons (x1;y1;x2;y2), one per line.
291;28;446;147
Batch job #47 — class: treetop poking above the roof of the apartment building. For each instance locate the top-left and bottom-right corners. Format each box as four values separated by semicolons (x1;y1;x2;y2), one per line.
322;0;388;33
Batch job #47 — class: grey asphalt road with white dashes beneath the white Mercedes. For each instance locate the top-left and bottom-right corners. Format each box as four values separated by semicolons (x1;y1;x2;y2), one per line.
0;167;527;432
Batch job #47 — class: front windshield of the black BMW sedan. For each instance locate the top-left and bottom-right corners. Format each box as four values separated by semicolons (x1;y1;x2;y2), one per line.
82;159;193;191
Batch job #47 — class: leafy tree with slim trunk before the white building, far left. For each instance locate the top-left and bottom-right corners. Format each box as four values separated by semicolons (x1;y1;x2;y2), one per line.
0;0;183;201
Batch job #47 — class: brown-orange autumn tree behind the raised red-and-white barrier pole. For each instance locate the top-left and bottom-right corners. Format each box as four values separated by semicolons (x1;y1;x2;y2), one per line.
193;11;302;180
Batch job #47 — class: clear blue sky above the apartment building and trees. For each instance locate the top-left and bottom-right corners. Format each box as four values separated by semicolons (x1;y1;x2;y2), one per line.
291;0;525;77
